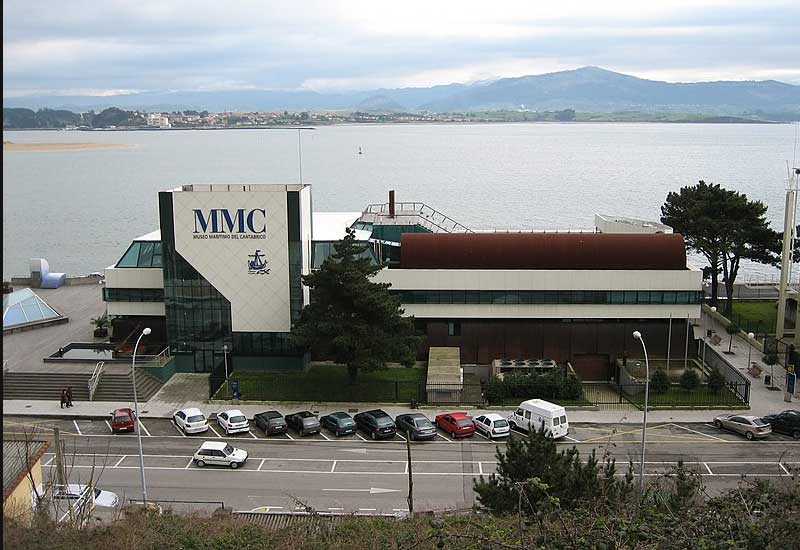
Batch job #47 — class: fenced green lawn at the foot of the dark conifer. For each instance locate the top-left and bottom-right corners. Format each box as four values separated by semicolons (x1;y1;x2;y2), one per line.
222;365;427;403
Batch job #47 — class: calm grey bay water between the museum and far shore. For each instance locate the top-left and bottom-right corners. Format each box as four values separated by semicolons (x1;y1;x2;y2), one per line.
3;123;796;278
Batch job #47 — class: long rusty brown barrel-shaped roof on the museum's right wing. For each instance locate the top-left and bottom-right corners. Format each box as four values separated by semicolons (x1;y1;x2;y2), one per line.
400;233;686;270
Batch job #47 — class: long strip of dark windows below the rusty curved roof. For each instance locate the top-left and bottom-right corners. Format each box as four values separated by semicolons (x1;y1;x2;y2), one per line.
390;290;703;305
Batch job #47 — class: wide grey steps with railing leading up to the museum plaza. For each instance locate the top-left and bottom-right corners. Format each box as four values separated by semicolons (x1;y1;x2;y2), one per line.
3;372;163;402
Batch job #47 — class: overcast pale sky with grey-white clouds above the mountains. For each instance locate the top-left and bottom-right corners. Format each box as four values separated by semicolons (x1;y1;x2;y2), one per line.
3;0;800;97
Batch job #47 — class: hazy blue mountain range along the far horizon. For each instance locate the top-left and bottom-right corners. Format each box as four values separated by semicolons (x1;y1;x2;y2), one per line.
3;67;800;119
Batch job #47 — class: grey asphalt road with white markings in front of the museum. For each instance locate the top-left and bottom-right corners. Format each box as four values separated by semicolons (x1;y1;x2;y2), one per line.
3;417;800;513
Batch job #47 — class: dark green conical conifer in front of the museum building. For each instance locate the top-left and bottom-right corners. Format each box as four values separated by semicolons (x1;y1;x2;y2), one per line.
292;229;419;382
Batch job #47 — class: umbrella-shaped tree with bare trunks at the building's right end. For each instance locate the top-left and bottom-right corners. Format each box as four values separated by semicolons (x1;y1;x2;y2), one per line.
661;180;780;315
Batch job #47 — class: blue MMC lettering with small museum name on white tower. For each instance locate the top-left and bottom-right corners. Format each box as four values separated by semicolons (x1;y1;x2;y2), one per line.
192;208;267;239
